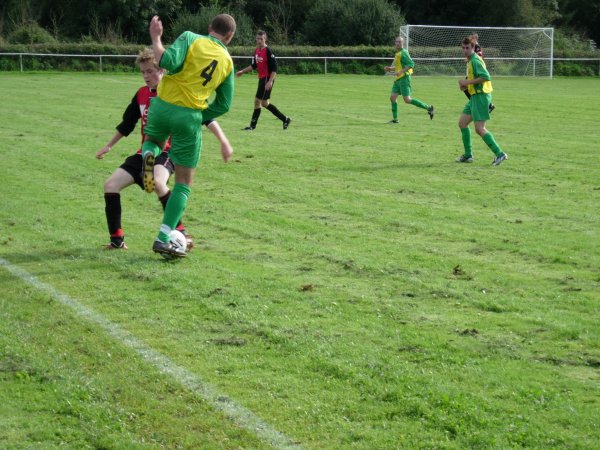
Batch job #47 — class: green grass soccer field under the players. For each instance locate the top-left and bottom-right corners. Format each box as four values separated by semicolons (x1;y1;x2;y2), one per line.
0;73;600;449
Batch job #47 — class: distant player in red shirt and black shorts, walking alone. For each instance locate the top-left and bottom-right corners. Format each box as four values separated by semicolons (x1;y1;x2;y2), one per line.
235;30;292;131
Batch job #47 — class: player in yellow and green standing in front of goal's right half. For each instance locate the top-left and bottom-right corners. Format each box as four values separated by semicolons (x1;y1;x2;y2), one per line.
456;36;508;166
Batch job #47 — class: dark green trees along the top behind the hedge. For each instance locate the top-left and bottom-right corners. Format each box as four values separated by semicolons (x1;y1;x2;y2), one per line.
0;0;600;46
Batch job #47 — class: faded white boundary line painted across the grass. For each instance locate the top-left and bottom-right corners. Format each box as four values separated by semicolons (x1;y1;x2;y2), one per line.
0;258;301;449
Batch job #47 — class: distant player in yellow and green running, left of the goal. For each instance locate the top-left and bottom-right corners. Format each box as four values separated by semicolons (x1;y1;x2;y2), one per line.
385;36;434;123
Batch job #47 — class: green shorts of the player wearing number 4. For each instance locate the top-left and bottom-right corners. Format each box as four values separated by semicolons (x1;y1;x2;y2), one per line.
144;97;202;169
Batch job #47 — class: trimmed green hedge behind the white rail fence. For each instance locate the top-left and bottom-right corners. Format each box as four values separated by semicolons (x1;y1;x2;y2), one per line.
0;42;600;76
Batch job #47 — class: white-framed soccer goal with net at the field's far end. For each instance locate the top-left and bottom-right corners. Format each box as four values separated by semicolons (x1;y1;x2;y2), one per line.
400;25;554;78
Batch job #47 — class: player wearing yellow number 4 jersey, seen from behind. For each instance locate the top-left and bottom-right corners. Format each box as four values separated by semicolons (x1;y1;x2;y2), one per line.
142;14;236;259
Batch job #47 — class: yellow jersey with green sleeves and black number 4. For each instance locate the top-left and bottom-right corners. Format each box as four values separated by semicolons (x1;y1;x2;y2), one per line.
157;31;233;110
